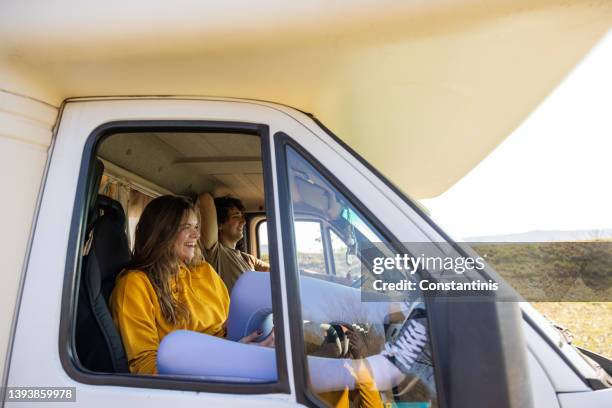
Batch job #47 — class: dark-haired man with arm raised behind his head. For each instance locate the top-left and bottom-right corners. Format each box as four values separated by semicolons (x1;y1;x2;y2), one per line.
198;193;270;293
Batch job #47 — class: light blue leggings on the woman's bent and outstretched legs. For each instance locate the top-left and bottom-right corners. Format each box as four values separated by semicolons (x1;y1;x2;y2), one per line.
157;272;416;392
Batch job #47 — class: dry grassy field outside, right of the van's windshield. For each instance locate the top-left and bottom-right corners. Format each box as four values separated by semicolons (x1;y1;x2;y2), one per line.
473;245;612;358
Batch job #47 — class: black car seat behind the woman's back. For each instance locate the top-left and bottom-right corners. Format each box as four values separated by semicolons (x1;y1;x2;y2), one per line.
75;163;131;373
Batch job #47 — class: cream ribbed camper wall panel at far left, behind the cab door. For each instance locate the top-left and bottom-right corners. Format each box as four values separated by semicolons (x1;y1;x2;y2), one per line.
0;89;58;386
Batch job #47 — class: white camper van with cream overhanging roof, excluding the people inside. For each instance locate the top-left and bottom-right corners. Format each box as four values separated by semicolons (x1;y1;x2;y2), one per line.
0;1;612;408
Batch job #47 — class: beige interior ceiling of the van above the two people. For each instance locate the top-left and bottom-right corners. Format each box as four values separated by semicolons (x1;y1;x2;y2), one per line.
98;132;264;203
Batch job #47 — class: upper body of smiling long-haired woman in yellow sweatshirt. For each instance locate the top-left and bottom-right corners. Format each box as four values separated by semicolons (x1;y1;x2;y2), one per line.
110;195;274;374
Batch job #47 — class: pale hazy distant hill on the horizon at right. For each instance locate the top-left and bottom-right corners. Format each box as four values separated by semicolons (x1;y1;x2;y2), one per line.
465;229;612;242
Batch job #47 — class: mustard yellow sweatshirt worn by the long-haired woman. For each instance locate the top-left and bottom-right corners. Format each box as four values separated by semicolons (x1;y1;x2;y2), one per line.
110;262;229;374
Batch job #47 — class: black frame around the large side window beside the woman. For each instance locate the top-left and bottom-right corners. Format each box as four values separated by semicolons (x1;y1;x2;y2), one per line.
58;120;291;394
